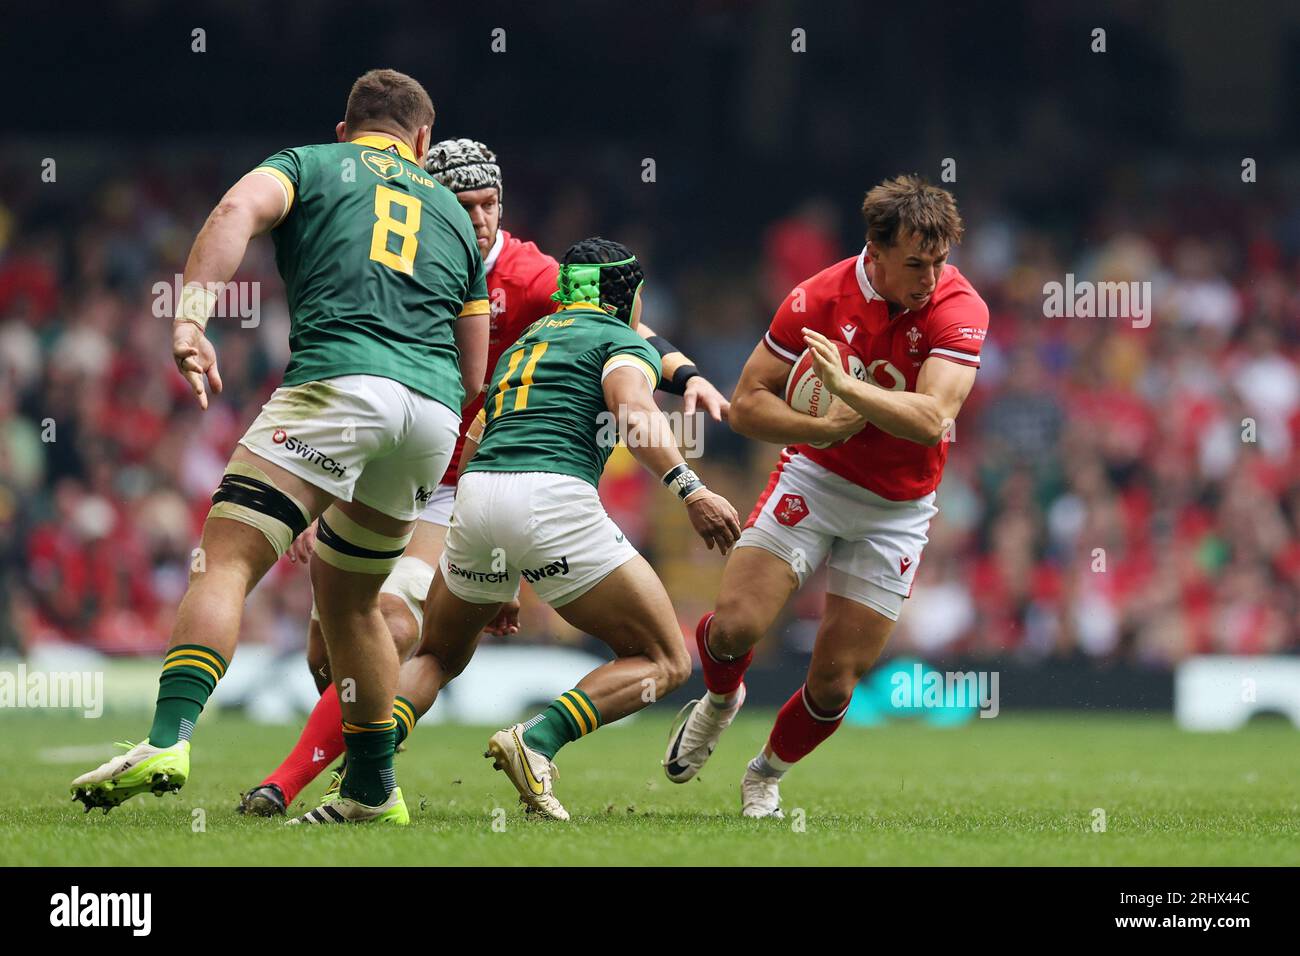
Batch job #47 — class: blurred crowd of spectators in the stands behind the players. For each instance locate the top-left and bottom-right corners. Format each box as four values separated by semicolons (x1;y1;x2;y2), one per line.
0;156;1300;666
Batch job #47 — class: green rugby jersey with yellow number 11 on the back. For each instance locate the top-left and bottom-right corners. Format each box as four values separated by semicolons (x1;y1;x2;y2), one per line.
465;302;660;485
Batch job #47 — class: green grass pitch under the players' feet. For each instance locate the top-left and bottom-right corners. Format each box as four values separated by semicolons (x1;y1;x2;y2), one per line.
0;709;1300;866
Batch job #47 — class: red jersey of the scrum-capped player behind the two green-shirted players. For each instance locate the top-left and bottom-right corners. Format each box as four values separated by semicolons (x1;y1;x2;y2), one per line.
442;229;560;485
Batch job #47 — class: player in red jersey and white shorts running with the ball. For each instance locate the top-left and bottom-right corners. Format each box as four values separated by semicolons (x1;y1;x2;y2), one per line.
663;176;988;817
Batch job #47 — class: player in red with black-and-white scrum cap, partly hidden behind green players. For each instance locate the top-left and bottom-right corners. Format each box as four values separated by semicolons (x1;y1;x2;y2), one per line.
238;139;731;817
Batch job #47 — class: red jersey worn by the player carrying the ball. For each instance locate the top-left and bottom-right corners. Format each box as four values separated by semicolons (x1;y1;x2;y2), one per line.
763;250;988;501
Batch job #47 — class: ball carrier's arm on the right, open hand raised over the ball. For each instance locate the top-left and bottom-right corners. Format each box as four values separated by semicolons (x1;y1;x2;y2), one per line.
803;330;975;445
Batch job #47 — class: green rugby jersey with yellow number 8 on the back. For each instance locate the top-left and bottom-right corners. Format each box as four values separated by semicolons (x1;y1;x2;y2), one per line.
254;135;489;411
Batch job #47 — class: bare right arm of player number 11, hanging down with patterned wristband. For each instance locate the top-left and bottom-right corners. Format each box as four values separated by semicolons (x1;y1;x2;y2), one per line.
605;367;740;554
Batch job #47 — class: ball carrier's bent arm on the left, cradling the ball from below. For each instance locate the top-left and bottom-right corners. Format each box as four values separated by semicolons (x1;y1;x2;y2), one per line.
731;342;866;445
